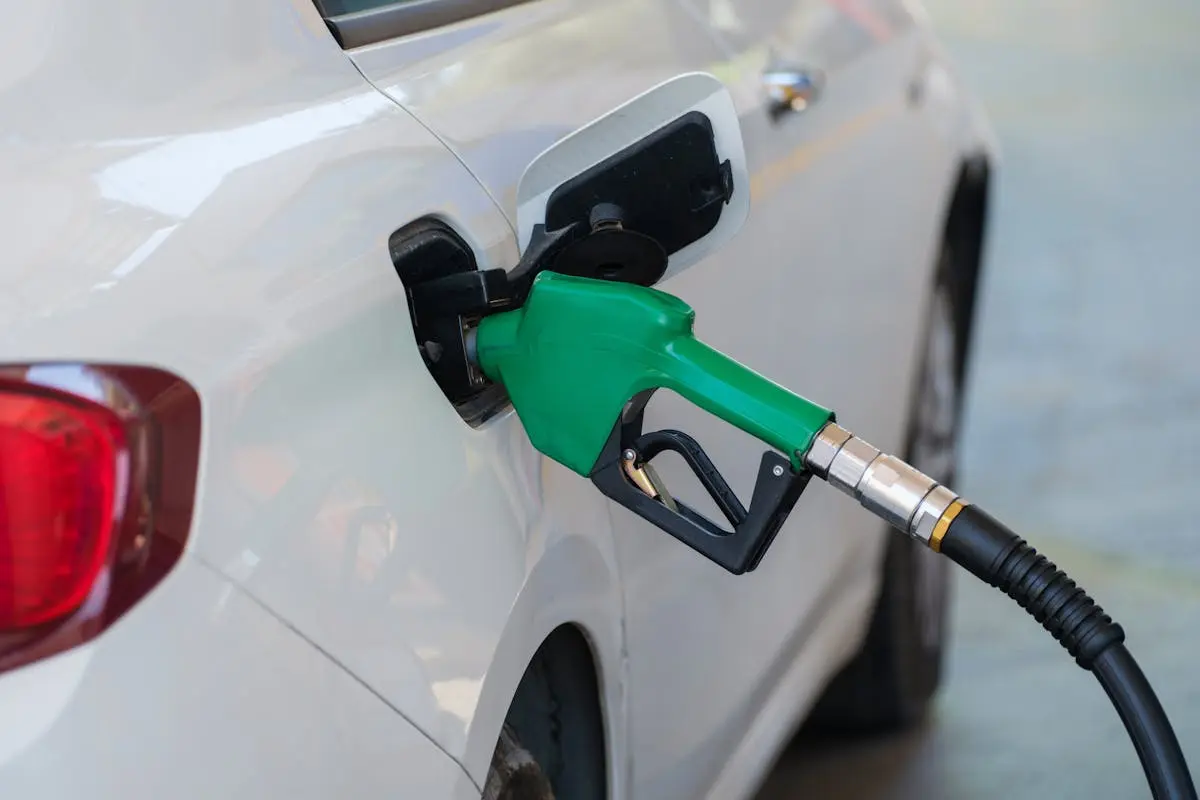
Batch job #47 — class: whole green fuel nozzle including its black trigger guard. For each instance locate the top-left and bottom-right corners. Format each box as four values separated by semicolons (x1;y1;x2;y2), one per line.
473;271;833;573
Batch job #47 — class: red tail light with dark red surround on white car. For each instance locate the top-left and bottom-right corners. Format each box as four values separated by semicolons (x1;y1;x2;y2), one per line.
0;365;199;672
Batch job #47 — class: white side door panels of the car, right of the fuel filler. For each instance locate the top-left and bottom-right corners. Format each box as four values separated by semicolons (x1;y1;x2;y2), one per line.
340;0;974;796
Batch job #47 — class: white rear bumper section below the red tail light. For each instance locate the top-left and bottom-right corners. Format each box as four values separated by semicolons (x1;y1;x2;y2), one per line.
0;558;479;800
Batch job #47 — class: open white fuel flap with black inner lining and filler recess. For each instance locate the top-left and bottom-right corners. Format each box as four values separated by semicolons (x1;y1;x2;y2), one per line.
391;73;750;423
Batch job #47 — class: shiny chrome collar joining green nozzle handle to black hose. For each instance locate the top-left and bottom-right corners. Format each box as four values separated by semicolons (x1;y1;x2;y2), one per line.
804;422;959;545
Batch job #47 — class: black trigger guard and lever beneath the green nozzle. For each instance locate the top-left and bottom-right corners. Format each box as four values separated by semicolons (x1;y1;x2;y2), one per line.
589;402;811;575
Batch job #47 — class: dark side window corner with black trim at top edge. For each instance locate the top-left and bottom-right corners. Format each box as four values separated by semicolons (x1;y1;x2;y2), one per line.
318;0;533;50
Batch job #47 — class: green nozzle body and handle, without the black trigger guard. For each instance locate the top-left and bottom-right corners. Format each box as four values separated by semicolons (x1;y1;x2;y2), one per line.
474;272;833;476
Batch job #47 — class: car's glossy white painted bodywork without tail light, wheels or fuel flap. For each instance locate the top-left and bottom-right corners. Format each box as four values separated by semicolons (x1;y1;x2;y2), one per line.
0;0;991;798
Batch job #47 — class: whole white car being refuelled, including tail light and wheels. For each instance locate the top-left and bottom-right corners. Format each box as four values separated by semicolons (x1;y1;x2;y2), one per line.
0;0;995;800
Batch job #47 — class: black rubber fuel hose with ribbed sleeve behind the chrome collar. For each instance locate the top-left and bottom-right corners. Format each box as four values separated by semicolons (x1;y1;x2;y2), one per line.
930;504;1196;800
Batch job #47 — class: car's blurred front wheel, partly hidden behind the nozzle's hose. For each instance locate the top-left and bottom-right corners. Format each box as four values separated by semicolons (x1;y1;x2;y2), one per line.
810;247;970;733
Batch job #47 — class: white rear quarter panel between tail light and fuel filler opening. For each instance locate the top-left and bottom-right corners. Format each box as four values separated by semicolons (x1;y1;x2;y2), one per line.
0;0;622;777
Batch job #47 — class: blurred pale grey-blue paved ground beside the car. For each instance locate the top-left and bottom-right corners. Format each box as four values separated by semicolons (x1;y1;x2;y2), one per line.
760;0;1200;800
